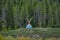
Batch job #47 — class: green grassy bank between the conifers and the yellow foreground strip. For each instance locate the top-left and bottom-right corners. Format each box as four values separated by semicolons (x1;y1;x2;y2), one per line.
0;28;60;38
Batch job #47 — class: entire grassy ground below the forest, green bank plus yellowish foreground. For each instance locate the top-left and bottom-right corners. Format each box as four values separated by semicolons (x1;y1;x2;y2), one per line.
0;28;60;40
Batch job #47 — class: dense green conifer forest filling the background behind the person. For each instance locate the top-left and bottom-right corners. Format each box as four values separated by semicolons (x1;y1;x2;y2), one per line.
0;0;60;30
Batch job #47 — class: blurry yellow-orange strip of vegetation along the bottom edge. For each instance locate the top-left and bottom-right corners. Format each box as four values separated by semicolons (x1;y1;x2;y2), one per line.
0;36;60;40
